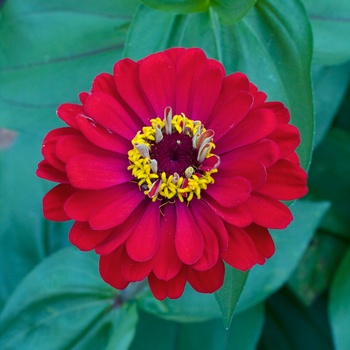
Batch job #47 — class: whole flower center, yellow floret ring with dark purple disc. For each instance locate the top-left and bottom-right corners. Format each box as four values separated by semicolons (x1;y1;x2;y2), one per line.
128;107;220;202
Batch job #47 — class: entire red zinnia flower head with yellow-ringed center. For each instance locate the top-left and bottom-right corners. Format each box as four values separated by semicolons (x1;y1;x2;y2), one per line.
37;48;307;299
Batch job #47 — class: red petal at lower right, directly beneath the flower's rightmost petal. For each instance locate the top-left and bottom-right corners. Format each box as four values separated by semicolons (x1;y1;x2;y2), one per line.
246;193;293;229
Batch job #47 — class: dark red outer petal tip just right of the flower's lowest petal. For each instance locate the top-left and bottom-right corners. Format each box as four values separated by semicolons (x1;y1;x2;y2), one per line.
188;259;225;293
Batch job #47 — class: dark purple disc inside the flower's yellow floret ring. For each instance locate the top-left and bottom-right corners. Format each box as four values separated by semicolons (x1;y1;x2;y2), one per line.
150;132;200;176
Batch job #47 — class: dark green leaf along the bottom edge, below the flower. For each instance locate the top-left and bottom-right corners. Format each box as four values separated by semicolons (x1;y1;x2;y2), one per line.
130;305;264;350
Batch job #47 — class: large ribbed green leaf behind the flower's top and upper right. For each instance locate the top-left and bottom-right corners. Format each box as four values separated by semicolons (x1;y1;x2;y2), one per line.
125;0;313;168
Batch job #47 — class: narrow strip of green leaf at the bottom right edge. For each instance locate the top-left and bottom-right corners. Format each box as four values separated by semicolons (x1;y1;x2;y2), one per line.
329;249;350;350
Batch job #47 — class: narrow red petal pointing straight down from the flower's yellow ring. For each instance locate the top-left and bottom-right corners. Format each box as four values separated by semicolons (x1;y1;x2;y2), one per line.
153;204;182;281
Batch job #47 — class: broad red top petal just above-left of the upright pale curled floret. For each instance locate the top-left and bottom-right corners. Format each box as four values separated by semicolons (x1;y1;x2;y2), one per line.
139;52;175;118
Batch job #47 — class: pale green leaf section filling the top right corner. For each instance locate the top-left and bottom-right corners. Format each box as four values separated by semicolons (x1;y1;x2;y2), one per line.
302;0;350;65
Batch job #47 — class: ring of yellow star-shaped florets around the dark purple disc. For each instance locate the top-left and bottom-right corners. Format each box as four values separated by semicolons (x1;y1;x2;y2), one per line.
128;107;220;202
